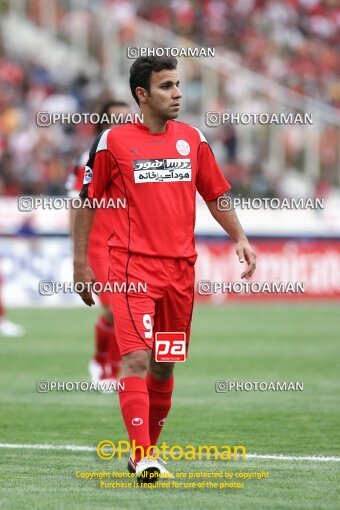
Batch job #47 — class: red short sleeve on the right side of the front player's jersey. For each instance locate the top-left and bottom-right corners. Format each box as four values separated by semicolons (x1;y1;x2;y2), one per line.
196;142;231;202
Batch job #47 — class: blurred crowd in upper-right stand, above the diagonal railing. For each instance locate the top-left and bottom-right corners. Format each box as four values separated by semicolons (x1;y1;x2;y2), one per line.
139;0;340;106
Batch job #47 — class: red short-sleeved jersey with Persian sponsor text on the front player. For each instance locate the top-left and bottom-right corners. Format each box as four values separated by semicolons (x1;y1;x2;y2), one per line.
80;121;230;258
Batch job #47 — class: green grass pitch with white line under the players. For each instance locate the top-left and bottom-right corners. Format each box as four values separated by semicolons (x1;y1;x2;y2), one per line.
0;303;340;510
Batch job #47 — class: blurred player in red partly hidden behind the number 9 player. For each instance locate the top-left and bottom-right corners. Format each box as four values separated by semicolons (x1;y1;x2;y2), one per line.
66;101;130;382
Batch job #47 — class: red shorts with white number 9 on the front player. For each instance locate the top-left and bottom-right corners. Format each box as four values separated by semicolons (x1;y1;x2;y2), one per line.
109;249;195;356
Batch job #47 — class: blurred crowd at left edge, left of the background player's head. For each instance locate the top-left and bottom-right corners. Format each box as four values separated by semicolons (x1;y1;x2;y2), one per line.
0;51;108;196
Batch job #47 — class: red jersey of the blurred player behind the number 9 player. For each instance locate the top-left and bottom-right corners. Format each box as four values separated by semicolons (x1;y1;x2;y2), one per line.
66;151;112;254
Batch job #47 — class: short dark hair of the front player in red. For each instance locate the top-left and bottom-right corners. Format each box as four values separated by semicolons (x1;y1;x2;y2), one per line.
130;57;177;105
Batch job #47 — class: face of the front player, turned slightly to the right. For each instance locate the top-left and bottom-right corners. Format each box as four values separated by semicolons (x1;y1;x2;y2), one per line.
146;69;182;119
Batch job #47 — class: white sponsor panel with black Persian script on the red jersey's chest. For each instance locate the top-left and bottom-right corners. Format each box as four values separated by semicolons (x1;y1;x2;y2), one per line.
133;158;191;184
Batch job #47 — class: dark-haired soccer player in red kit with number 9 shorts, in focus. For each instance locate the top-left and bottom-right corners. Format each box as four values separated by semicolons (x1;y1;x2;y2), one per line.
74;57;255;482
